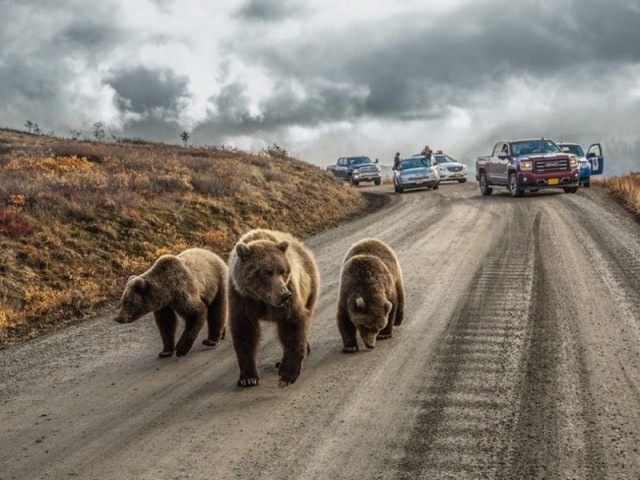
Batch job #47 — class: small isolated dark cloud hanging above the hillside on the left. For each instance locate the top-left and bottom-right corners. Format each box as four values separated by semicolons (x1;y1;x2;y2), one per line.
105;67;189;114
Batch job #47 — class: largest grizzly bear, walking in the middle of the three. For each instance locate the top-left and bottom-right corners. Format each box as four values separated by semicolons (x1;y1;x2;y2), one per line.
229;229;320;387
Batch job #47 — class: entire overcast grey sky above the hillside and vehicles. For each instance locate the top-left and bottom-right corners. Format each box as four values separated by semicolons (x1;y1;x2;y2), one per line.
0;0;640;174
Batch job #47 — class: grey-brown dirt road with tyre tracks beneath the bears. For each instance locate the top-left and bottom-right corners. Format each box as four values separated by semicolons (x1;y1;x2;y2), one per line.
0;182;640;480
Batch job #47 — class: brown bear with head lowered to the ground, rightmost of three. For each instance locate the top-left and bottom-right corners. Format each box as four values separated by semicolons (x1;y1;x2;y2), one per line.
337;238;404;353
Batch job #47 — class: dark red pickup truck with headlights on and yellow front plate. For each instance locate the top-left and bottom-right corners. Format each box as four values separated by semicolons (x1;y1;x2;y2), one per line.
476;138;580;197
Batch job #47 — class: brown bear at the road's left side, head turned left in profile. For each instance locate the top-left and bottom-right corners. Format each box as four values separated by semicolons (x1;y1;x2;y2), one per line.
114;248;228;358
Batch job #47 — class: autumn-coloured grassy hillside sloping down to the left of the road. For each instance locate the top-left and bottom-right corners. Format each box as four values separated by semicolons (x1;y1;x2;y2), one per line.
0;129;367;348
